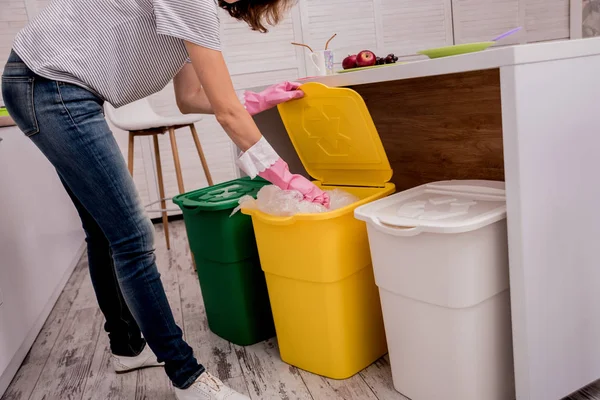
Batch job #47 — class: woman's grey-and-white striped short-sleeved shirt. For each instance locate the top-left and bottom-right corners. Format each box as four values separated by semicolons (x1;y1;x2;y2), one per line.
13;0;220;107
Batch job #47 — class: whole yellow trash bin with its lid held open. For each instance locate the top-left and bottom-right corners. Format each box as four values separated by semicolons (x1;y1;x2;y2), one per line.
242;83;395;379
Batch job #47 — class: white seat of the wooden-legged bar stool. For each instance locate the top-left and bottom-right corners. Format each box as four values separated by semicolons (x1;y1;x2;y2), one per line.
104;98;202;131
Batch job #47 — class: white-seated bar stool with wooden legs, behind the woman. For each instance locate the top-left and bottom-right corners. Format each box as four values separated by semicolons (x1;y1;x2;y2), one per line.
104;98;213;250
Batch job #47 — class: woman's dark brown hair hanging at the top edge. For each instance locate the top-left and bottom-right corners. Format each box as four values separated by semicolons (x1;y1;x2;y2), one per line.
219;0;295;33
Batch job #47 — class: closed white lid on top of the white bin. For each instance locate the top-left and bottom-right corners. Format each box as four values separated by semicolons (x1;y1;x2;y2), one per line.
355;180;506;236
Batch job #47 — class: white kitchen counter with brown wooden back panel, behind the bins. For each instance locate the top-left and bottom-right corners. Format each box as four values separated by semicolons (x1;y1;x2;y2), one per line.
253;38;600;400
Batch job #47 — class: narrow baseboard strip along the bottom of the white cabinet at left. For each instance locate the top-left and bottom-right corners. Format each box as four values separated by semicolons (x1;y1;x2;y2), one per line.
0;242;86;397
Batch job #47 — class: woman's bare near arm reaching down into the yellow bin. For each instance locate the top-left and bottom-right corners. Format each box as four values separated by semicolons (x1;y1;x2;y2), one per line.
185;41;262;152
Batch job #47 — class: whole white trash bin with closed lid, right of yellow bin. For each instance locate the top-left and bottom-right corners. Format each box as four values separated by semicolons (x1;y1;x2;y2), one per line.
355;181;515;400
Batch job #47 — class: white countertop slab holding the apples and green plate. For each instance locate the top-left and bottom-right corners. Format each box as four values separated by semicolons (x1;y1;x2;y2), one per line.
249;38;600;91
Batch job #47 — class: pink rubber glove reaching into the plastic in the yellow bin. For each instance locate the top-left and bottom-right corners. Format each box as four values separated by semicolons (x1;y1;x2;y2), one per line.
258;158;329;208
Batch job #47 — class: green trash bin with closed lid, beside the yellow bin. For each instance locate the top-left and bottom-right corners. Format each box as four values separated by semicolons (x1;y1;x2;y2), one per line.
173;177;275;346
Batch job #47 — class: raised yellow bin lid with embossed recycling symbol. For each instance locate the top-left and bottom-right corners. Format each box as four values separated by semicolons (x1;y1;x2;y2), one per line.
277;82;393;187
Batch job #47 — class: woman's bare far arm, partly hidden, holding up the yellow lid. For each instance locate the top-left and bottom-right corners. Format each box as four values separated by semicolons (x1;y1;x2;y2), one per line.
173;63;213;114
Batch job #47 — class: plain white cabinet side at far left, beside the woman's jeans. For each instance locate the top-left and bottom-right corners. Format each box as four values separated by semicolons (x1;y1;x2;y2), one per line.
0;127;84;397
